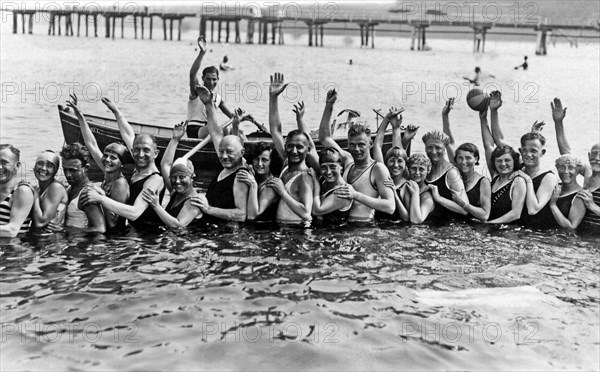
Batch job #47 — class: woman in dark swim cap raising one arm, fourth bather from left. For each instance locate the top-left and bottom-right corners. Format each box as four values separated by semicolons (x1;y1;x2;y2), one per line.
67;94;129;231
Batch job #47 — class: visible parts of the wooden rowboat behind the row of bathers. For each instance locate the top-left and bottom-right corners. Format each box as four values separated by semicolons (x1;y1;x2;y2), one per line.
58;105;404;186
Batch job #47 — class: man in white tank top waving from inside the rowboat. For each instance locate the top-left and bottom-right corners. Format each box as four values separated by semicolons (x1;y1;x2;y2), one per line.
186;36;233;139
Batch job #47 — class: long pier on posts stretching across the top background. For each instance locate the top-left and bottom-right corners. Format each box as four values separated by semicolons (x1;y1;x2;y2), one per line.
2;3;600;55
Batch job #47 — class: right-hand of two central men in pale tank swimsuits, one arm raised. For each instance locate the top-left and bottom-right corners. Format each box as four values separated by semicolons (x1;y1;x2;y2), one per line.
319;89;396;222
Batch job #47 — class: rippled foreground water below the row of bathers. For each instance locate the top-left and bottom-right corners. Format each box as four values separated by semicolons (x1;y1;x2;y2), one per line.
1;224;600;370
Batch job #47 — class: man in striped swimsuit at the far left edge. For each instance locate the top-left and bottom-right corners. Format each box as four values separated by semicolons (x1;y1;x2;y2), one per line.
0;144;34;238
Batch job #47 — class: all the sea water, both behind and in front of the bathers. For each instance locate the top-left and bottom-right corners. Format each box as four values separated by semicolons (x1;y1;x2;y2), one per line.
0;16;600;370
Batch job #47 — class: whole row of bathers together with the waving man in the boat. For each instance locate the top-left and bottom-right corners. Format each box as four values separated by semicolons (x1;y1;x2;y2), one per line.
0;40;600;237
